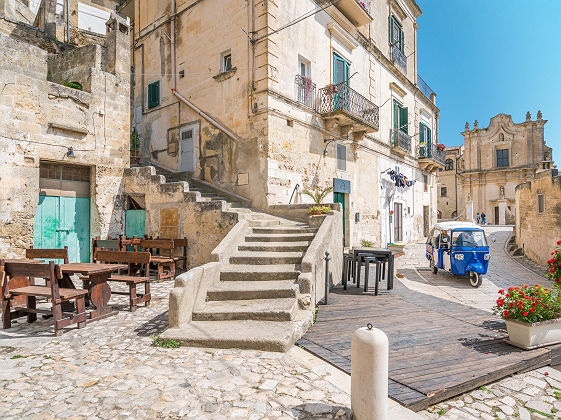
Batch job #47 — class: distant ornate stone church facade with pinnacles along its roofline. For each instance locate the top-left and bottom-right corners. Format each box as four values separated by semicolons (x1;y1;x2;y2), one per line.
439;111;553;225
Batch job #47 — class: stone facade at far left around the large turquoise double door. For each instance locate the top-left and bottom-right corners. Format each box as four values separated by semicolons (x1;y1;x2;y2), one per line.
0;7;130;257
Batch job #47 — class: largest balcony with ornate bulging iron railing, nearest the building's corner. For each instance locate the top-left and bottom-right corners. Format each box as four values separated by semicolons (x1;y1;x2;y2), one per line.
319;83;380;141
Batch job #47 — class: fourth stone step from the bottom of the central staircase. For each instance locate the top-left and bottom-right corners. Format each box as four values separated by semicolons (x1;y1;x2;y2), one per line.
220;264;300;281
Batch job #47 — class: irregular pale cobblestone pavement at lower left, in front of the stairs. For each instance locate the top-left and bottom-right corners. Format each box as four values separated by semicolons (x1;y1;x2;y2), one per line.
0;282;350;420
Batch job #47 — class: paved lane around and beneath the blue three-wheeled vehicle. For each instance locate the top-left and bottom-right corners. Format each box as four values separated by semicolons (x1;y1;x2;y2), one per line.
396;226;551;312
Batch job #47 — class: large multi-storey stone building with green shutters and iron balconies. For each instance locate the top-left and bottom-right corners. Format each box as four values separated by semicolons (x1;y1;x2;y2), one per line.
120;0;444;245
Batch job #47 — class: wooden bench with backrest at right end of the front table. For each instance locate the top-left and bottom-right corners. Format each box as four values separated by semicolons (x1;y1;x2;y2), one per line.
97;251;151;312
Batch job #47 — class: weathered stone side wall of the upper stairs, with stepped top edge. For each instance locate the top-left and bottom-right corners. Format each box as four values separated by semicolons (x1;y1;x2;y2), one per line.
123;166;238;269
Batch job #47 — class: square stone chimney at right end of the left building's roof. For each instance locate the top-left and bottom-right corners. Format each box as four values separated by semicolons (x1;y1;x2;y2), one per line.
105;13;130;77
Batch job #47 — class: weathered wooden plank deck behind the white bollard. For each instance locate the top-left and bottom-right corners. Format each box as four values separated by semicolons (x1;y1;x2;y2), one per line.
298;270;561;411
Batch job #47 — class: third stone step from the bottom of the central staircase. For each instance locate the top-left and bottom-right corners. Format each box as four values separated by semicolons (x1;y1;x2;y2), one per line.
207;280;299;301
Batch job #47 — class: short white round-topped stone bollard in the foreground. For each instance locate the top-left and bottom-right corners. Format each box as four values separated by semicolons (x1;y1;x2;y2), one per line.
351;324;388;420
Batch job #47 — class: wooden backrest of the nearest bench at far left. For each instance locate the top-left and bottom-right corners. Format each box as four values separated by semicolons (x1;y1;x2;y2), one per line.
0;260;62;303
